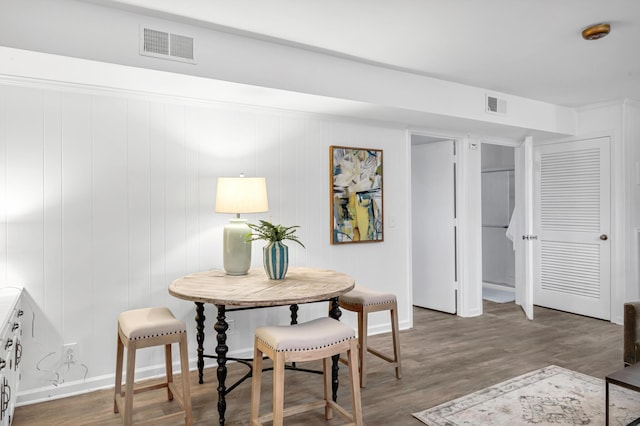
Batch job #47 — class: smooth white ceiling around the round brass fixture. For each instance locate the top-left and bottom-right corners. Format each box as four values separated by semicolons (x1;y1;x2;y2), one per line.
101;0;640;107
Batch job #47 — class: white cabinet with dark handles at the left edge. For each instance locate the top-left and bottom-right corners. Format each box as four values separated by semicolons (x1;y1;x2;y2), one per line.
0;288;24;426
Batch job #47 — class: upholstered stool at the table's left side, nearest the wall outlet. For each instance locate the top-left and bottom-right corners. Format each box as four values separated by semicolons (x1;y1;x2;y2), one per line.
113;307;191;425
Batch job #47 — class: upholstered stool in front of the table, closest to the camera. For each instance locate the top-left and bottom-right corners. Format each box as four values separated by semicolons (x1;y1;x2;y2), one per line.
251;318;362;426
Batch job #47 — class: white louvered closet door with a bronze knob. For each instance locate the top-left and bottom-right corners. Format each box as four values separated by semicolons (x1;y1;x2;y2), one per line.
533;138;611;319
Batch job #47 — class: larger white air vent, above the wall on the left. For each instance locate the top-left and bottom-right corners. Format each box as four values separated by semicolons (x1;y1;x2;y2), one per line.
140;27;195;64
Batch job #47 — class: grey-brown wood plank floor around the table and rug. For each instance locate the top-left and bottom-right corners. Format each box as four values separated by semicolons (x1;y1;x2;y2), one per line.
13;301;623;426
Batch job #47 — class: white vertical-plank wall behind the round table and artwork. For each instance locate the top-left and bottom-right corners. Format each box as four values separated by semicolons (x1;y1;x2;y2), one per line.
0;83;411;403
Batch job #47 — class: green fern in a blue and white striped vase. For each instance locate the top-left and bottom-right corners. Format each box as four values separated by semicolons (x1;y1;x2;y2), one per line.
246;220;304;280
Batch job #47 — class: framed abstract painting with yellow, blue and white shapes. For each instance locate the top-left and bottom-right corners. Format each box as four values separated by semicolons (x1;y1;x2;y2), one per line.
329;146;384;244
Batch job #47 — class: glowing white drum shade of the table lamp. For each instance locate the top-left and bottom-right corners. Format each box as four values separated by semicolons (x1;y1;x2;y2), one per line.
216;177;269;214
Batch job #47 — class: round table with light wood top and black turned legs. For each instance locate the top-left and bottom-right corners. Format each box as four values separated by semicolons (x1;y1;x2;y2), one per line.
169;267;355;425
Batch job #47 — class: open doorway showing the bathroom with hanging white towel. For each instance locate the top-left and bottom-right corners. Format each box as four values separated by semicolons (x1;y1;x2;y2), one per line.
481;143;516;303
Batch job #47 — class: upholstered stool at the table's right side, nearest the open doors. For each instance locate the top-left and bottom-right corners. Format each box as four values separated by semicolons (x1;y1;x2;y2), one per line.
338;285;402;387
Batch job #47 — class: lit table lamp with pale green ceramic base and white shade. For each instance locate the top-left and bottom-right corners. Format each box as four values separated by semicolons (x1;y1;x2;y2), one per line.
216;174;269;275
